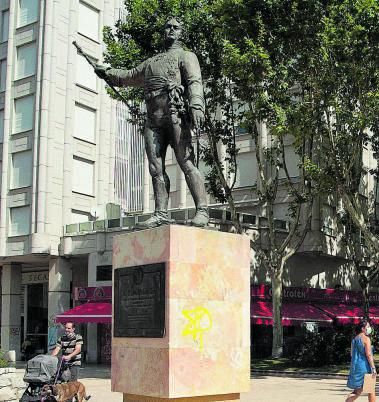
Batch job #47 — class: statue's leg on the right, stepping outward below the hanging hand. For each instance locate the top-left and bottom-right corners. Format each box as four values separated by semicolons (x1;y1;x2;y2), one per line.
172;124;209;226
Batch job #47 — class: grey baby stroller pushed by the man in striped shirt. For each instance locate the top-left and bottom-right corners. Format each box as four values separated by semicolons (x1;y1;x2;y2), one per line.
20;355;66;402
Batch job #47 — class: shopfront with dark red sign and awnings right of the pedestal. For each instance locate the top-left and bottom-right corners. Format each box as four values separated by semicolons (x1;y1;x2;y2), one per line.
251;285;379;357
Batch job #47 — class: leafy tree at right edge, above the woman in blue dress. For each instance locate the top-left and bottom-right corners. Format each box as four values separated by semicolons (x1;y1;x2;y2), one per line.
284;0;379;317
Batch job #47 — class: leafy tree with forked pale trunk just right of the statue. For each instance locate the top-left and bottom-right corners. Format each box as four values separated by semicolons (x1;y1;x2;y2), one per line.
206;0;332;357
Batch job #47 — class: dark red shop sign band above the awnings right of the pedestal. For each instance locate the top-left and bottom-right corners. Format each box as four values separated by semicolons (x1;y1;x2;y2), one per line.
251;285;379;304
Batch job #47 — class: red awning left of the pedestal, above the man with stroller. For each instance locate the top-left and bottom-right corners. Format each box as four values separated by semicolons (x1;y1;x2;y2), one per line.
55;303;112;324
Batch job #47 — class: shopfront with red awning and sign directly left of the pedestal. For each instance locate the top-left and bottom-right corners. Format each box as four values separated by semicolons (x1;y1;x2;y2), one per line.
55;286;112;364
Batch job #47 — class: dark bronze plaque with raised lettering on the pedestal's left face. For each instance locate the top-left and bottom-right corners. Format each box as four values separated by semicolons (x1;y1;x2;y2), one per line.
114;263;166;338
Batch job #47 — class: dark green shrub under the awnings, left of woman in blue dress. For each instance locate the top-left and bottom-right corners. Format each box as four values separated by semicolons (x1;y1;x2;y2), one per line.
289;326;353;367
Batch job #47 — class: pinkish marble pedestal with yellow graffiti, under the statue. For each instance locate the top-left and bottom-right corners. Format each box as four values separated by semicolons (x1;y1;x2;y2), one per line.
112;225;250;402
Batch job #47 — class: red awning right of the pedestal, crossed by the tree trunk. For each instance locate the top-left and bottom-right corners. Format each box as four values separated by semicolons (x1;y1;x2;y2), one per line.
251;300;333;326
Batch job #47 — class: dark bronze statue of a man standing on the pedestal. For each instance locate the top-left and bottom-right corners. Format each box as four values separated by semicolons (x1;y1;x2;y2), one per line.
95;18;209;227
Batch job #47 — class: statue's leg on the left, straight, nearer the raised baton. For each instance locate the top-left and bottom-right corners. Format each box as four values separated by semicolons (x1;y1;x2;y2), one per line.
138;124;172;227
